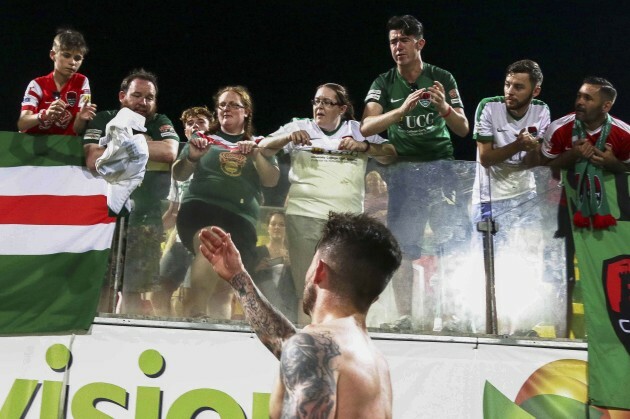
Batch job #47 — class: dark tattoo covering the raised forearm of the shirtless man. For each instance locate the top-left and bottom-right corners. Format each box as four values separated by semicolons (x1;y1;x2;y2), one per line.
230;272;296;358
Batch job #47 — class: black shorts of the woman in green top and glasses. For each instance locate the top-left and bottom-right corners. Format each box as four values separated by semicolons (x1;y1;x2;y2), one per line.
177;200;258;272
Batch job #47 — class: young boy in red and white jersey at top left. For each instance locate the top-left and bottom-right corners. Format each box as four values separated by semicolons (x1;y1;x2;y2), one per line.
18;29;96;135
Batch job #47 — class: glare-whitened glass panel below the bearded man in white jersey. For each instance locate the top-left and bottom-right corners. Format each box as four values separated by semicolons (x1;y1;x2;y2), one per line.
491;168;568;338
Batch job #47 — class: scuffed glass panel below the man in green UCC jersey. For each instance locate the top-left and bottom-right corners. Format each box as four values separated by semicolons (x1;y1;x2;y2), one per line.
365;161;483;333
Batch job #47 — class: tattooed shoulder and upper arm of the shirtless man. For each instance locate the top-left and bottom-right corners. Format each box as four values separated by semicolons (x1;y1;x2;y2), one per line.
270;332;341;418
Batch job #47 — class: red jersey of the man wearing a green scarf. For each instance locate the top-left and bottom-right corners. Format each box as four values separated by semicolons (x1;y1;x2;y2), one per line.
541;113;630;163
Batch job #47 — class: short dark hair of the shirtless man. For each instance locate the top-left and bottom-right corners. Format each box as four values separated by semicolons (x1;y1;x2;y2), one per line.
317;212;402;311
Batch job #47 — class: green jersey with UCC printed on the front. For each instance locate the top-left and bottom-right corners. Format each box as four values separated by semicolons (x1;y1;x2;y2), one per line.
365;63;463;161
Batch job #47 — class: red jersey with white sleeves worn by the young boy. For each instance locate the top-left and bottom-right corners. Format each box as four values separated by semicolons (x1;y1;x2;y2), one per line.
22;72;91;135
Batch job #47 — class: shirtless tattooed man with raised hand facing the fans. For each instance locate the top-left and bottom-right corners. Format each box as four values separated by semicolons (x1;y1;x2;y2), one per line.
200;213;402;418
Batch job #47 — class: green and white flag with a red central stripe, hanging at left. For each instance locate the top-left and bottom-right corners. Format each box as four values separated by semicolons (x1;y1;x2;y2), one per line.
0;132;116;334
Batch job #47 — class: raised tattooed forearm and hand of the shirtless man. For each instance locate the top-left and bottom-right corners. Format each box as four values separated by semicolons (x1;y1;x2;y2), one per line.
199;227;296;359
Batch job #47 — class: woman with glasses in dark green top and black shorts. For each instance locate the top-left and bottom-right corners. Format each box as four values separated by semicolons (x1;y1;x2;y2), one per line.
173;86;280;319
